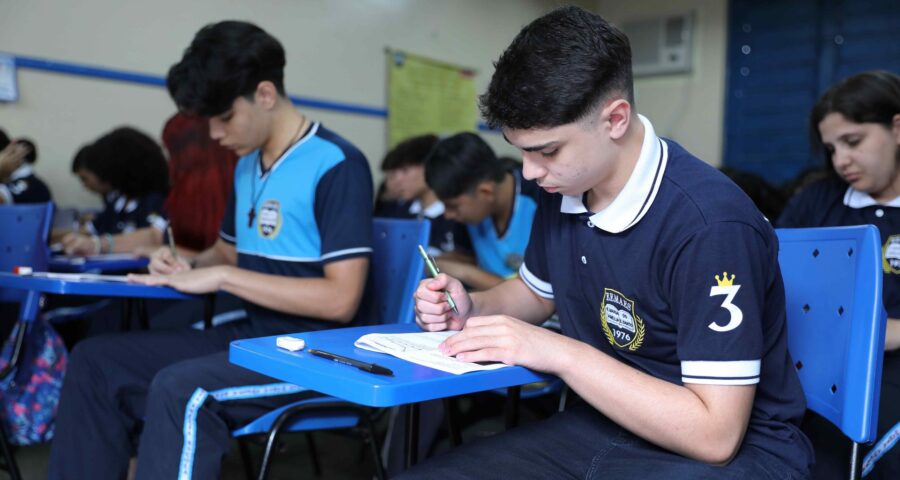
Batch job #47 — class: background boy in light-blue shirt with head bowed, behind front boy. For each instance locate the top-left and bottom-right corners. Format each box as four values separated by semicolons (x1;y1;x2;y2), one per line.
425;133;537;290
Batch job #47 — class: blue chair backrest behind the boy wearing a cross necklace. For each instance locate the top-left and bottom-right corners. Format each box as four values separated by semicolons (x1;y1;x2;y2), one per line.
357;218;431;325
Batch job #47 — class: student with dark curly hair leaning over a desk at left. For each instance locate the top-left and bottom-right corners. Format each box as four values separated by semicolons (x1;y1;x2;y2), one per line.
62;127;169;255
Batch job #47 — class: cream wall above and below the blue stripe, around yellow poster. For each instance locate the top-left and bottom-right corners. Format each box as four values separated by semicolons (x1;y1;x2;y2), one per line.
0;0;557;206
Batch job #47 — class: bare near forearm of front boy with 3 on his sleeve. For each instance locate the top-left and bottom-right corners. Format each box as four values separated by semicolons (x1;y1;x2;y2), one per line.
551;338;755;464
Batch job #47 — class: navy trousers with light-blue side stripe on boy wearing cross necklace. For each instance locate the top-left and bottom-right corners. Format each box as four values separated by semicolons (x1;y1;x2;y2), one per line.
49;321;315;479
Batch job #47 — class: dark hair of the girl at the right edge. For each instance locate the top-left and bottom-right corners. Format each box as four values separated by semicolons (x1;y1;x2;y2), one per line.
809;70;900;168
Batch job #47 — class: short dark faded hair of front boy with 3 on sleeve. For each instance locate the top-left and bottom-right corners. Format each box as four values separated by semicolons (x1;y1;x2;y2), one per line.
480;6;634;129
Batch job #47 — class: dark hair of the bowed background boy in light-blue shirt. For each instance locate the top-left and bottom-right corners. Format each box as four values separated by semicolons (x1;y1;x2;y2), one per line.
425;133;507;198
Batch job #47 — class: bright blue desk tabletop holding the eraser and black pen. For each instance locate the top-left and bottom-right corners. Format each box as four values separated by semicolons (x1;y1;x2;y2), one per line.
229;324;554;407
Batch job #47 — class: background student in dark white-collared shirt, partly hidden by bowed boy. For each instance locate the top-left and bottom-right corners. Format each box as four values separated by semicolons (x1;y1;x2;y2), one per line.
381;135;472;263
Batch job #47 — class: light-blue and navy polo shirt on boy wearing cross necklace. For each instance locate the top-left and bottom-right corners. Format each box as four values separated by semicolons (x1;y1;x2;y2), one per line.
219;123;372;330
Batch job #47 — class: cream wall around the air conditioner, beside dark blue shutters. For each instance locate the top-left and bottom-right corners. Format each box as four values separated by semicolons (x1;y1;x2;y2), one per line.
594;0;728;166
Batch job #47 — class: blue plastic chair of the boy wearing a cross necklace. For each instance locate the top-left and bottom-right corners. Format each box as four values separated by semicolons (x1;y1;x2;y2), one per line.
232;218;431;480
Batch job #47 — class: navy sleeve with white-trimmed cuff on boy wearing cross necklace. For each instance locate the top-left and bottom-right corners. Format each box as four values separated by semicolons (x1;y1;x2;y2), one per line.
315;158;372;263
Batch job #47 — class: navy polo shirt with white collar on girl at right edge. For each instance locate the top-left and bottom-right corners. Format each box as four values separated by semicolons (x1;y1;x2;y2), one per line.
776;179;900;318
